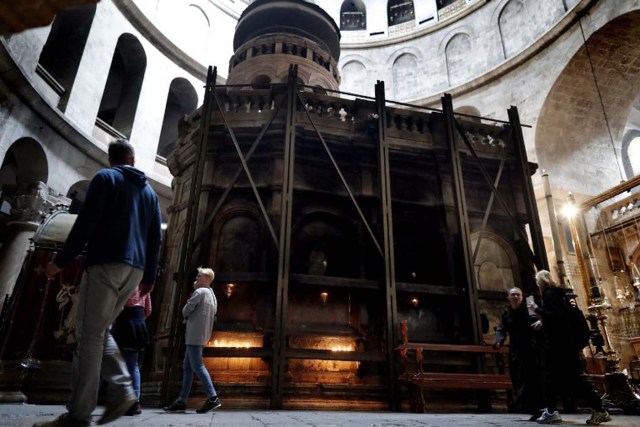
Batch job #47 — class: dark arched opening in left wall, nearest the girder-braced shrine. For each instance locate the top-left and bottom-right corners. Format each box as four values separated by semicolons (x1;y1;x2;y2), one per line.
157;77;198;158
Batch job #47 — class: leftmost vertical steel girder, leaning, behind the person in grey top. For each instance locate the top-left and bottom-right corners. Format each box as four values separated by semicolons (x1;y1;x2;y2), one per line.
160;67;218;402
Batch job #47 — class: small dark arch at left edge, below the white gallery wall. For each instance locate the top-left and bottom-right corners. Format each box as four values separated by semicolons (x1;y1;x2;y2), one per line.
0;137;49;189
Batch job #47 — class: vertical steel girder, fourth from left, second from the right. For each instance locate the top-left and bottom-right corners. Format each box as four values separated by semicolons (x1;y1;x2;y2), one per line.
442;94;482;344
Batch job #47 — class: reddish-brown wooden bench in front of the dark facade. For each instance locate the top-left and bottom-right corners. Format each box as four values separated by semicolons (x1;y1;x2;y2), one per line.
395;320;512;412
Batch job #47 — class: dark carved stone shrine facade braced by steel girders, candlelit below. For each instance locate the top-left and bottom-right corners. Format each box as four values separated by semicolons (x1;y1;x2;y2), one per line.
152;0;544;409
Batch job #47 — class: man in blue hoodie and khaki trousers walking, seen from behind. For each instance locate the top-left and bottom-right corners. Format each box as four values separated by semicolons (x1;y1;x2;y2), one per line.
34;140;162;427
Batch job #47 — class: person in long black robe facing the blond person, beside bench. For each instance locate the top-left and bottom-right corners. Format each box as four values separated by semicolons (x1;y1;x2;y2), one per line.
493;288;543;421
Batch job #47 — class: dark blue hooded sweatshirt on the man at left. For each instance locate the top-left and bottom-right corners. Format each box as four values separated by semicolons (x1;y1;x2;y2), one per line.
54;165;162;284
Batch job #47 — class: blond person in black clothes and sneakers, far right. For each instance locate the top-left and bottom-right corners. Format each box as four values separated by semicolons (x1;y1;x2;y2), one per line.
528;270;611;425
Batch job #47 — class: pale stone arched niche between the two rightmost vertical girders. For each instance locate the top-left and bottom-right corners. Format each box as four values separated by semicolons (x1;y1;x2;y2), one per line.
471;231;520;294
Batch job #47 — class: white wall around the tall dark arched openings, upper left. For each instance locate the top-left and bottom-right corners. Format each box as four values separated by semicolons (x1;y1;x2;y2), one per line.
0;1;208;201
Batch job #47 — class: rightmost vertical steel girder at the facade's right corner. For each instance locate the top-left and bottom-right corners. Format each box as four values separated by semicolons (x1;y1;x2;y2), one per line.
508;106;549;270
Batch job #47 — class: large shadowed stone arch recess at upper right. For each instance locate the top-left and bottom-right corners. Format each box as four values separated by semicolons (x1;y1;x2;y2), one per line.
535;10;640;195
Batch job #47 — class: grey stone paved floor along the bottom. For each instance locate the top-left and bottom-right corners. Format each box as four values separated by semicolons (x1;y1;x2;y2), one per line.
0;404;640;427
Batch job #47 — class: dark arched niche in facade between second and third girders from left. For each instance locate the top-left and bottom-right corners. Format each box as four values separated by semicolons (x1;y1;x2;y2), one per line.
291;211;360;278
